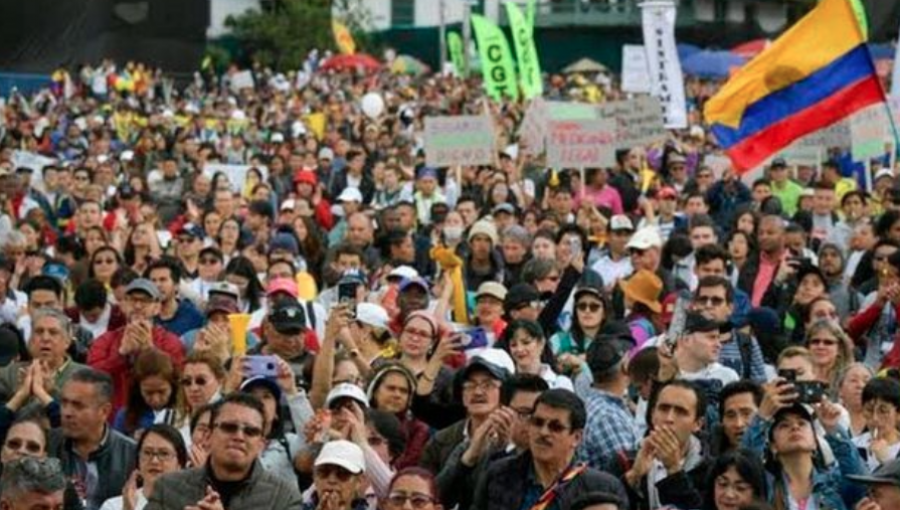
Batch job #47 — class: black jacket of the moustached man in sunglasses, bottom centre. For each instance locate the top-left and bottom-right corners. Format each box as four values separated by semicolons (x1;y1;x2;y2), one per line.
472;452;624;510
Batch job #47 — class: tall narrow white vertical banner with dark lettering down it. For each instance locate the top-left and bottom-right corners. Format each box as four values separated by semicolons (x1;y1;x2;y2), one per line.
641;0;687;129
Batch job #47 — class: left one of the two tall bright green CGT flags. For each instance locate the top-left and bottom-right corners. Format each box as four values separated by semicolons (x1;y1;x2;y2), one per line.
472;14;519;101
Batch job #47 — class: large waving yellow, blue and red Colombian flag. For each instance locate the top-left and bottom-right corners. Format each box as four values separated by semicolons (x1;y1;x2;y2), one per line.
704;0;885;172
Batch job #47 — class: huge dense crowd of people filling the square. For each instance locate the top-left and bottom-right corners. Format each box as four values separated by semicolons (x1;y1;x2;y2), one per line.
0;55;900;510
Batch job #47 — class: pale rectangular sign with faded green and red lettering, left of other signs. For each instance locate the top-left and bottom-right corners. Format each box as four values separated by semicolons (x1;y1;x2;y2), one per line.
425;115;495;167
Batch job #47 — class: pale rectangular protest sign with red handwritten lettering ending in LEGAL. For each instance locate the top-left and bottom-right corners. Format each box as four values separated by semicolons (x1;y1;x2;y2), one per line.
547;119;616;168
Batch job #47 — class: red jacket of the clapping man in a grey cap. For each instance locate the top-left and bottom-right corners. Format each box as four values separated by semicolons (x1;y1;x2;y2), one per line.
87;326;184;416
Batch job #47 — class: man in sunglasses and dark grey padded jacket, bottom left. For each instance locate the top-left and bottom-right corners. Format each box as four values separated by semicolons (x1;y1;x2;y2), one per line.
146;393;301;510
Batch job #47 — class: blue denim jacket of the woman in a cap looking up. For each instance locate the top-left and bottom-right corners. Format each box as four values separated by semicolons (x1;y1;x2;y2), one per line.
741;416;868;510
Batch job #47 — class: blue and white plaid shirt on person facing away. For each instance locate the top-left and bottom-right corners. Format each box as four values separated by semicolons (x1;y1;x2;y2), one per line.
578;388;637;473
